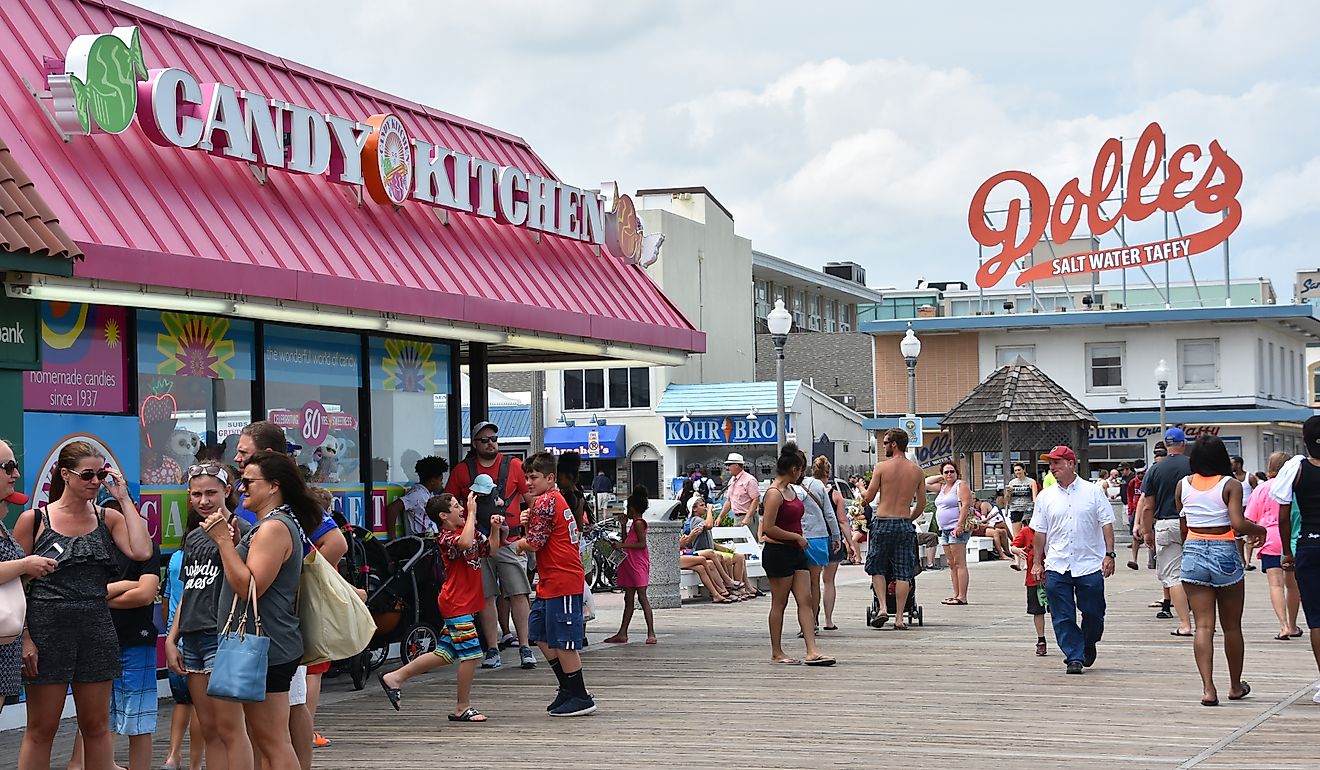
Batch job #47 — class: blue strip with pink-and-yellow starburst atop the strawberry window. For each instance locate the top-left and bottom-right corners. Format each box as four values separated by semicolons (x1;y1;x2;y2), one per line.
137;310;256;380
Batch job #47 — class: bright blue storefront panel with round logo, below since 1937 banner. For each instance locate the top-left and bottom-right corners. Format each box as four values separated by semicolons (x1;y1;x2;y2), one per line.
22;412;141;515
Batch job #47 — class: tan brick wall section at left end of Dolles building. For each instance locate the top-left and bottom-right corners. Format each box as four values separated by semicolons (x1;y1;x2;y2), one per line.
875;332;981;415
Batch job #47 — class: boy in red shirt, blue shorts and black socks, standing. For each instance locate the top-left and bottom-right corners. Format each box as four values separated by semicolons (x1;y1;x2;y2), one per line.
515;452;595;717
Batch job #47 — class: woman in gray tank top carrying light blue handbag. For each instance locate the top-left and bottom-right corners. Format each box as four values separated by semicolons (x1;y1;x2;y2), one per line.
211;452;321;770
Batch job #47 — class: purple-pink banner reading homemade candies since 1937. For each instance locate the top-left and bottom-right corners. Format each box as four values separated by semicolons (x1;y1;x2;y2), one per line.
22;302;128;412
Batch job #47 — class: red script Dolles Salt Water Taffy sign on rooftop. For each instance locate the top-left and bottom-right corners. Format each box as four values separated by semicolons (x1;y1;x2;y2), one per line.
968;123;1242;288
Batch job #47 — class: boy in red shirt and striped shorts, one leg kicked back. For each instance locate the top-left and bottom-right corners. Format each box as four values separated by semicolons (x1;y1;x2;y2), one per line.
376;493;504;722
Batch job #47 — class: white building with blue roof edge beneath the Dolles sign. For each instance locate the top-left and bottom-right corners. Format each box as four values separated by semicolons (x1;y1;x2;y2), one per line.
862;305;1320;483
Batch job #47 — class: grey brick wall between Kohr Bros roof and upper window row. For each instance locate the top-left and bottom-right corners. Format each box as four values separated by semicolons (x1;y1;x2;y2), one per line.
756;332;874;415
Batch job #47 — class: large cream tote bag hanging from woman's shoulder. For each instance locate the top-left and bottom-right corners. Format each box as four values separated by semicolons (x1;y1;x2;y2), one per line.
298;548;376;664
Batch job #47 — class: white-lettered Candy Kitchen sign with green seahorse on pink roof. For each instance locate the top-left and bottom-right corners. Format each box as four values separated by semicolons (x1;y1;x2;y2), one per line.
46;26;663;264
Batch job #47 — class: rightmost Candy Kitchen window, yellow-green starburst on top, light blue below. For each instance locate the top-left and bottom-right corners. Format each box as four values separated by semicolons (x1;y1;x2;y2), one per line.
370;337;451;532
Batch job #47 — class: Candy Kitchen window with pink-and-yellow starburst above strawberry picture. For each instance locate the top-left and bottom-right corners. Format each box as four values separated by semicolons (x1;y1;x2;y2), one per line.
136;310;255;549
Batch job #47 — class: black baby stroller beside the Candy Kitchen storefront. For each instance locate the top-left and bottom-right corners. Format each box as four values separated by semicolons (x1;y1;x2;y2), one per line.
347;527;445;670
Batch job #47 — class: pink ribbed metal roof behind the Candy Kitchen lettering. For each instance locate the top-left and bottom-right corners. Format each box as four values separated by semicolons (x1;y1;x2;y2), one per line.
0;0;705;351
